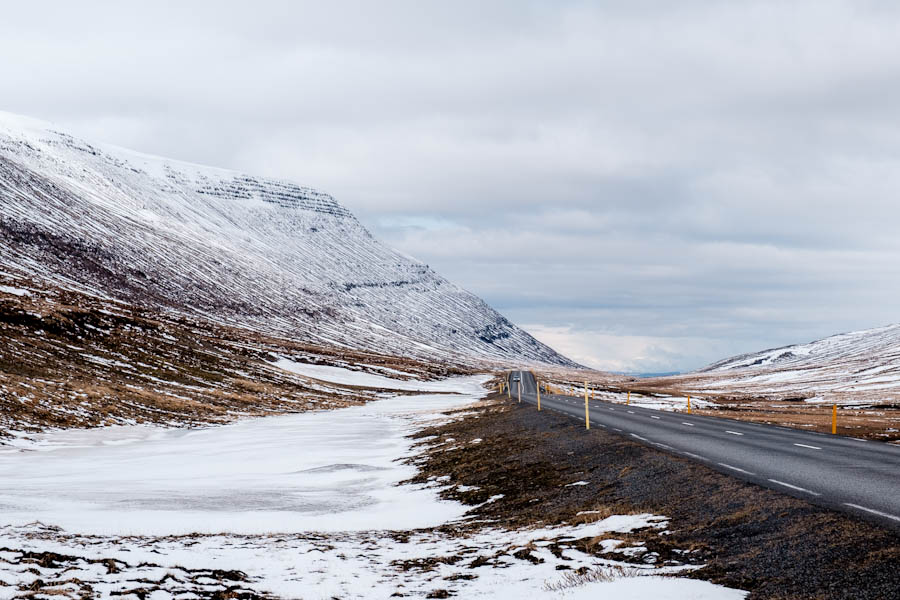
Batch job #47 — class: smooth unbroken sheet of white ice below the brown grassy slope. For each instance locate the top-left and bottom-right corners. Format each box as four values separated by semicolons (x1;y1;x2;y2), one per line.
0;376;487;535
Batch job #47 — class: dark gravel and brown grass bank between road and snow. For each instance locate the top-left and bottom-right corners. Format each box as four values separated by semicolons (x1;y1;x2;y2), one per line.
413;395;900;600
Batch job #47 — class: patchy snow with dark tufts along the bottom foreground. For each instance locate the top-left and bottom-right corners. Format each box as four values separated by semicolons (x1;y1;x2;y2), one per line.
0;515;745;600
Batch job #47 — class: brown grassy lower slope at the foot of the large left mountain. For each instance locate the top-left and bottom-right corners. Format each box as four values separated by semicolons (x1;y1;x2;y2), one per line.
0;275;466;440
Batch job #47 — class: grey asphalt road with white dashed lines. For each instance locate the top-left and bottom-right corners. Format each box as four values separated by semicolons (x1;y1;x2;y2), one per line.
508;371;900;528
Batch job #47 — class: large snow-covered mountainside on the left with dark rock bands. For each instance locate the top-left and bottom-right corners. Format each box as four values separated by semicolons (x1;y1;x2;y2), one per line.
0;113;572;365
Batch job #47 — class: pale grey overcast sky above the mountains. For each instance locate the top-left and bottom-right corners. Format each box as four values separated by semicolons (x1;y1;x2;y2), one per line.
0;0;900;371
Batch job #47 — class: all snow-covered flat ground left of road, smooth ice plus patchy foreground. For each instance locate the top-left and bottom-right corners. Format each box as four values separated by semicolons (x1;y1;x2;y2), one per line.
0;370;744;600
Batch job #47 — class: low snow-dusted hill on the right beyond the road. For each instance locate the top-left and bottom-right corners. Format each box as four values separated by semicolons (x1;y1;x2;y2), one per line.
661;325;900;402
